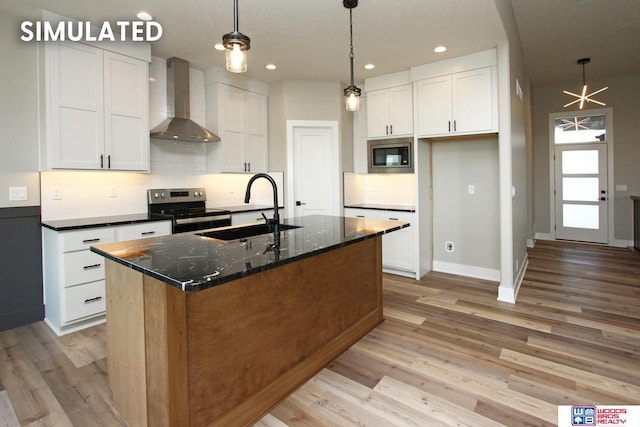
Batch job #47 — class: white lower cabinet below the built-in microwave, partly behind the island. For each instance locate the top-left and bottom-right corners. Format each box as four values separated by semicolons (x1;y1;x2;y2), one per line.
344;208;416;277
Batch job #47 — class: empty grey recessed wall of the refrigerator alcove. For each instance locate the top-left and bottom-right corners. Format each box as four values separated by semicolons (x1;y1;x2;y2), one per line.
432;136;500;281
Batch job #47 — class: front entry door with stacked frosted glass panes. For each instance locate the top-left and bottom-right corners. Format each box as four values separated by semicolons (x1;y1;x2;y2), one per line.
555;143;608;243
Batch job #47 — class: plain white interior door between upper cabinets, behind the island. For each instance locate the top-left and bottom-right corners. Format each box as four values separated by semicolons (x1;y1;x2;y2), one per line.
289;125;340;216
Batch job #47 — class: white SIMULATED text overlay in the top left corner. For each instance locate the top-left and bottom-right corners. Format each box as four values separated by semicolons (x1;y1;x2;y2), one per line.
20;21;162;42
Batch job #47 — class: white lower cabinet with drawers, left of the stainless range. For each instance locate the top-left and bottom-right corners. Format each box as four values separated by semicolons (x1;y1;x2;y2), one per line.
42;221;171;335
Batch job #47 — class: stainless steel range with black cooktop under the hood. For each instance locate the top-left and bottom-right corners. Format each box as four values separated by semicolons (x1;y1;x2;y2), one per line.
147;188;231;233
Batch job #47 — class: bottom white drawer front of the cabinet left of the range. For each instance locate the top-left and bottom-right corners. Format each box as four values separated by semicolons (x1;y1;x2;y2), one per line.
62;280;106;323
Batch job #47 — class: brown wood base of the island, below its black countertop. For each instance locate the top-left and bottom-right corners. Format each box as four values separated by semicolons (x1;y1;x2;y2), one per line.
106;235;383;427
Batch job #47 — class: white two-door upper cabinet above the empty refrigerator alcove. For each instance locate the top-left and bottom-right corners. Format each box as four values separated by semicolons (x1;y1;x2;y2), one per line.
416;67;498;137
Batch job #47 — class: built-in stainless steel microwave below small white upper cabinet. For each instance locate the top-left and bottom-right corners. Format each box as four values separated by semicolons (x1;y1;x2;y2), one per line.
367;138;413;173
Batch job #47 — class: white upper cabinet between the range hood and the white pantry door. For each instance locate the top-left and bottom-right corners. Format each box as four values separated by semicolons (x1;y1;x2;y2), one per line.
207;83;268;173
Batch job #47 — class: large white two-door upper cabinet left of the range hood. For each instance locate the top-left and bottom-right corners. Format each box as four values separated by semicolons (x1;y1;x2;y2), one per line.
42;42;149;171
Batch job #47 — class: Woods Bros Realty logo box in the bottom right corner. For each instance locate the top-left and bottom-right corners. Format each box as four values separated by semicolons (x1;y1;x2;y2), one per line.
558;405;640;427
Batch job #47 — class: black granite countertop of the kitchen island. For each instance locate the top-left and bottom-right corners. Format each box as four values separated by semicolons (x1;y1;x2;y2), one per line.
91;215;409;292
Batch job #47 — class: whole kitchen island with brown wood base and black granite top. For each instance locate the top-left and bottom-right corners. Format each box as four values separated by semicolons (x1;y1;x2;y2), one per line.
91;216;409;426
